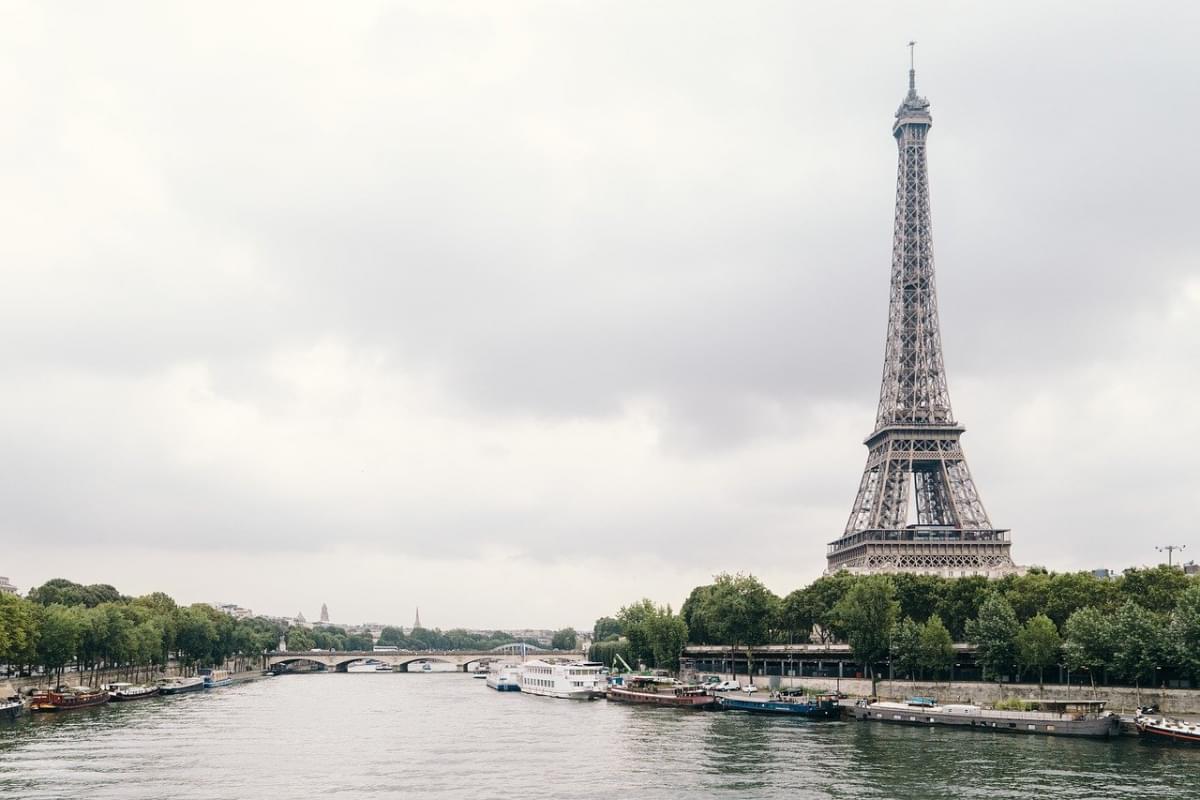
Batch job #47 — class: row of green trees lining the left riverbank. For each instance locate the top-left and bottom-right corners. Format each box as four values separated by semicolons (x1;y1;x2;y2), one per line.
0;578;283;681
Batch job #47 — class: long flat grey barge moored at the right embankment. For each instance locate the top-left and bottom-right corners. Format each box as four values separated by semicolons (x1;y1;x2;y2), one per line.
851;698;1121;736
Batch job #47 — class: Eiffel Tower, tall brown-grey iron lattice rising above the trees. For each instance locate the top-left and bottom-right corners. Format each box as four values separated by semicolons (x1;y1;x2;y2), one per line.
826;51;1016;577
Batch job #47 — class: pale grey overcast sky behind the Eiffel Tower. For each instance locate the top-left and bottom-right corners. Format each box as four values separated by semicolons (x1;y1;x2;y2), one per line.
0;0;1200;627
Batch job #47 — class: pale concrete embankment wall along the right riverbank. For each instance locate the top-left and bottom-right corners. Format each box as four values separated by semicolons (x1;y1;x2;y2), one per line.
725;674;1200;716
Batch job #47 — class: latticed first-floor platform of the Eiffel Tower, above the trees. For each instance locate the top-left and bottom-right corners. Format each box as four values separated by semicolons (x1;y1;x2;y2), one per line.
826;525;1024;578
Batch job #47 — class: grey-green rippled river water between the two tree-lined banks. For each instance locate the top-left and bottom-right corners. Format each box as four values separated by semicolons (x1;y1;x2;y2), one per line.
0;673;1200;800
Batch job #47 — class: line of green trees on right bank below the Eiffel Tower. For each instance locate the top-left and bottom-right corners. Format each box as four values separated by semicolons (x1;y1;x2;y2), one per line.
590;566;1200;685
